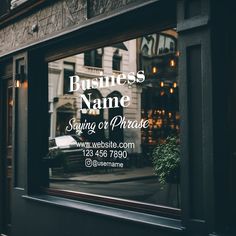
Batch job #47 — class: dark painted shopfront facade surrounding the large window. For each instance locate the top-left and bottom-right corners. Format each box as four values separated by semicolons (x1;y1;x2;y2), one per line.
0;0;236;236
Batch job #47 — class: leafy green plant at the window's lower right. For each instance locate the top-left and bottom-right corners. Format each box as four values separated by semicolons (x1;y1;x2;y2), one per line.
152;136;180;184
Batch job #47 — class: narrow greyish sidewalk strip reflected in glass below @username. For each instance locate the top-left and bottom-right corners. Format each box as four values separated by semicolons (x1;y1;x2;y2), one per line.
50;167;155;183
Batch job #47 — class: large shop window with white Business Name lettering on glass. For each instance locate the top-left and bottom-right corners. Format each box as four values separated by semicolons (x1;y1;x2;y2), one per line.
48;29;180;208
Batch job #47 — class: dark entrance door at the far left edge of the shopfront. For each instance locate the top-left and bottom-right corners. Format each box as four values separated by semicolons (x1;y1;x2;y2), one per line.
0;72;13;236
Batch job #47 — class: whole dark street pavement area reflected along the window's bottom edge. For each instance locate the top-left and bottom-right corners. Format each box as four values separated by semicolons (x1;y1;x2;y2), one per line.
50;167;178;207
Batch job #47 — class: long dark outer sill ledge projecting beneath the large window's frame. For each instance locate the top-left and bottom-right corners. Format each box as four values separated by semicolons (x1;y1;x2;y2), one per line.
23;195;183;232
